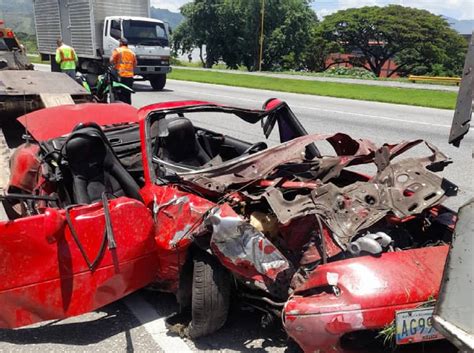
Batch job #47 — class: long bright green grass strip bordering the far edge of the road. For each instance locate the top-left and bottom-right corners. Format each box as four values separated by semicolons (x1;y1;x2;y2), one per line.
168;68;457;109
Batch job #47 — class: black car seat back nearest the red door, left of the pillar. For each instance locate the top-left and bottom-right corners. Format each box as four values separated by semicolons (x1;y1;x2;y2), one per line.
64;126;143;204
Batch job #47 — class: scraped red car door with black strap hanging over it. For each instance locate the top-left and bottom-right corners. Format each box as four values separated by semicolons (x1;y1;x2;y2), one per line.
0;197;158;328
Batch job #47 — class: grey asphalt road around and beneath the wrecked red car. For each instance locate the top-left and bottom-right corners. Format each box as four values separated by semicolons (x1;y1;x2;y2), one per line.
0;72;474;353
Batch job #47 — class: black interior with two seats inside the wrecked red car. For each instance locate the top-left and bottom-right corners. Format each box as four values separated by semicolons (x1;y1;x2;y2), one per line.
32;113;267;205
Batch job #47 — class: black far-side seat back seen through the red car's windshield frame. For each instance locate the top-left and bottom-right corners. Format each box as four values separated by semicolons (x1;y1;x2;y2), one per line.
158;117;211;167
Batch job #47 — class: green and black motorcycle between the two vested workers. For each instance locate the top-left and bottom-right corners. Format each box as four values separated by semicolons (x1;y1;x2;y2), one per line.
76;62;135;103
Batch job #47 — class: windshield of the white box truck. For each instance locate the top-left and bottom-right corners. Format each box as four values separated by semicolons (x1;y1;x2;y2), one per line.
122;20;168;47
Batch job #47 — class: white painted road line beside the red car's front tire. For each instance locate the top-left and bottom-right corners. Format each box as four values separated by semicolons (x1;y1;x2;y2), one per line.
124;293;192;353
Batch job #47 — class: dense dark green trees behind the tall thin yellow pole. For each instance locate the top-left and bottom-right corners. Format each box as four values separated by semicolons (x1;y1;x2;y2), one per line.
173;0;316;70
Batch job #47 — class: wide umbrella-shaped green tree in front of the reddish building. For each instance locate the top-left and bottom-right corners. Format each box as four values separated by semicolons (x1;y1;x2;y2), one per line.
321;5;467;76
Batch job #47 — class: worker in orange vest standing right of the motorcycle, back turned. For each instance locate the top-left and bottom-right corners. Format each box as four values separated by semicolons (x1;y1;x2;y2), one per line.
110;38;137;104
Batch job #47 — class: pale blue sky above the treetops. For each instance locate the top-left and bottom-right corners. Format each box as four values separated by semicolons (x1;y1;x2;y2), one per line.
151;0;474;20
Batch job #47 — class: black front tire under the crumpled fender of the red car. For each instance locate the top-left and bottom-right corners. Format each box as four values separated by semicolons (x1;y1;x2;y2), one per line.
188;251;231;338
